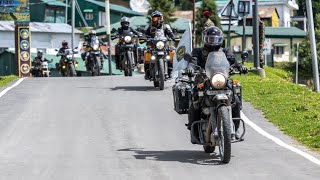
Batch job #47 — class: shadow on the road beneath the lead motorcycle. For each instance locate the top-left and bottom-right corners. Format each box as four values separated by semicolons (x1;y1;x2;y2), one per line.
118;148;223;165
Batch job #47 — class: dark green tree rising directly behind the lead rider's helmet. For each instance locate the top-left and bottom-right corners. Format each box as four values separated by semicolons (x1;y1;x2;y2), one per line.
196;0;222;43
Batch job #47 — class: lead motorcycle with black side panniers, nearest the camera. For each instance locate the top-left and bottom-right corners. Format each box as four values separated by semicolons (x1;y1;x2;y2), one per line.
174;51;245;163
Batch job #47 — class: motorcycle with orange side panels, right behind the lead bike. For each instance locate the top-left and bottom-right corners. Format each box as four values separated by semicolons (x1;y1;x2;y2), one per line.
140;29;180;90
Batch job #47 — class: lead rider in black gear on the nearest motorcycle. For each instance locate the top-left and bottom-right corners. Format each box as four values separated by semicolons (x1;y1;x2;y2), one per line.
186;26;248;139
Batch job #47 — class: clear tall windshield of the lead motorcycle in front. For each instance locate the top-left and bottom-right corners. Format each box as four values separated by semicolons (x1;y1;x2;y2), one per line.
206;51;230;78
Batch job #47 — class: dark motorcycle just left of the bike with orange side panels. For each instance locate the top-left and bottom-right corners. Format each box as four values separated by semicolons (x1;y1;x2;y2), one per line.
111;29;138;76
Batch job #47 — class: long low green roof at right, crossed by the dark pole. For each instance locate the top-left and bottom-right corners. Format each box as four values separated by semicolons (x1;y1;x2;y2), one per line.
222;25;307;38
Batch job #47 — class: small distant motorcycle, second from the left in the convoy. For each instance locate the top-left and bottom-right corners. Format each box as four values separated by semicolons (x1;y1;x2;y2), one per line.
55;47;78;77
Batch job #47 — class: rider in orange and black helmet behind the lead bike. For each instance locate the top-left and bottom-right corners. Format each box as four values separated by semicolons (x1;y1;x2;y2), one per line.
144;10;175;79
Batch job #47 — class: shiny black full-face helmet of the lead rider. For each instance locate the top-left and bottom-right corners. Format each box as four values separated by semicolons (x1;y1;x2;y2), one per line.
203;26;223;51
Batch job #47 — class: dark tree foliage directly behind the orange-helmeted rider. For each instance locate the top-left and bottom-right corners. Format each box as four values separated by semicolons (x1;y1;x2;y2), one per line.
148;0;176;24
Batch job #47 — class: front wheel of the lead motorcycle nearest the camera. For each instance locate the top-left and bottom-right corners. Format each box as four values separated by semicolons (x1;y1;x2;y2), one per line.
217;106;231;163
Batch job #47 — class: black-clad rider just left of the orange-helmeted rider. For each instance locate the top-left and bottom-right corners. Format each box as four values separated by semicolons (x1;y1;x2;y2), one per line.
115;16;142;69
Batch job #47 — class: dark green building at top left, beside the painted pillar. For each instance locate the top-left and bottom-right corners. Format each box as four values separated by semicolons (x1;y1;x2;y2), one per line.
29;0;70;23
